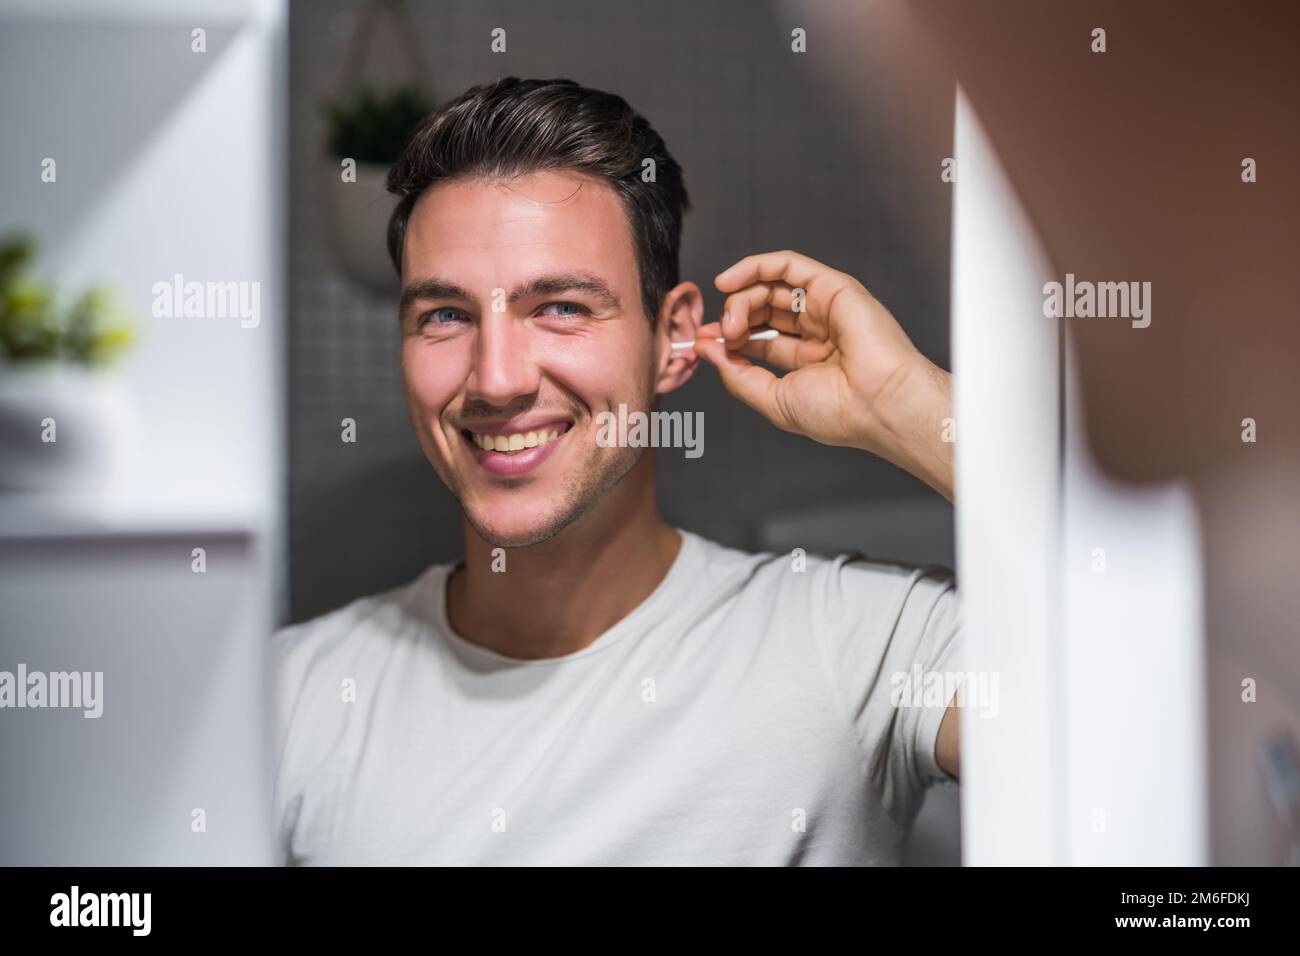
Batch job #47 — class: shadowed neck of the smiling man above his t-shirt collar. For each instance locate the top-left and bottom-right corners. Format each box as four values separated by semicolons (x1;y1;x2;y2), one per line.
447;454;681;659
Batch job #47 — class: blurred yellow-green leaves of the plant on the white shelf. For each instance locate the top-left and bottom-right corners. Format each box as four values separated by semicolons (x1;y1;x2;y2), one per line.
0;234;135;365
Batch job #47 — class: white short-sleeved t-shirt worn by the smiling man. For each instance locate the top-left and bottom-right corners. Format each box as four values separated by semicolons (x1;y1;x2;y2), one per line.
272;529;961;865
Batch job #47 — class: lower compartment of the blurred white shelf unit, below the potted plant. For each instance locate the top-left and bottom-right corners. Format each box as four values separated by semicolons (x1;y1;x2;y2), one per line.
0;510;270;866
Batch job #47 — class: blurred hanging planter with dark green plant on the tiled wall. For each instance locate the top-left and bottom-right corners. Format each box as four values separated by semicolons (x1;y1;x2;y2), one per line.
324;0;436;295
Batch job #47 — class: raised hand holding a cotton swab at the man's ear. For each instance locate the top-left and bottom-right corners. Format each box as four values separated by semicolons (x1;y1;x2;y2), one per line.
696;251;953;501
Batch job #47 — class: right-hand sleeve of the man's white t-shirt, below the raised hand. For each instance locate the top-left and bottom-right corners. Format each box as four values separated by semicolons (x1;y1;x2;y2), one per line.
814;554;962;823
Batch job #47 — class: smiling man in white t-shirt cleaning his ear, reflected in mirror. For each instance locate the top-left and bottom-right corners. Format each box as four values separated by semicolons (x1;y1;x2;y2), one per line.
274;78;959;865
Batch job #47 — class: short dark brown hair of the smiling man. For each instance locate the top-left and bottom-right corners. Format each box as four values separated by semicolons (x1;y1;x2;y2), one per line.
387;77;690;326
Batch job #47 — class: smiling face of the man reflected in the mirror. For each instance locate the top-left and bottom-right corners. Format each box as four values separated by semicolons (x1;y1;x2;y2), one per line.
402;172;658;548
